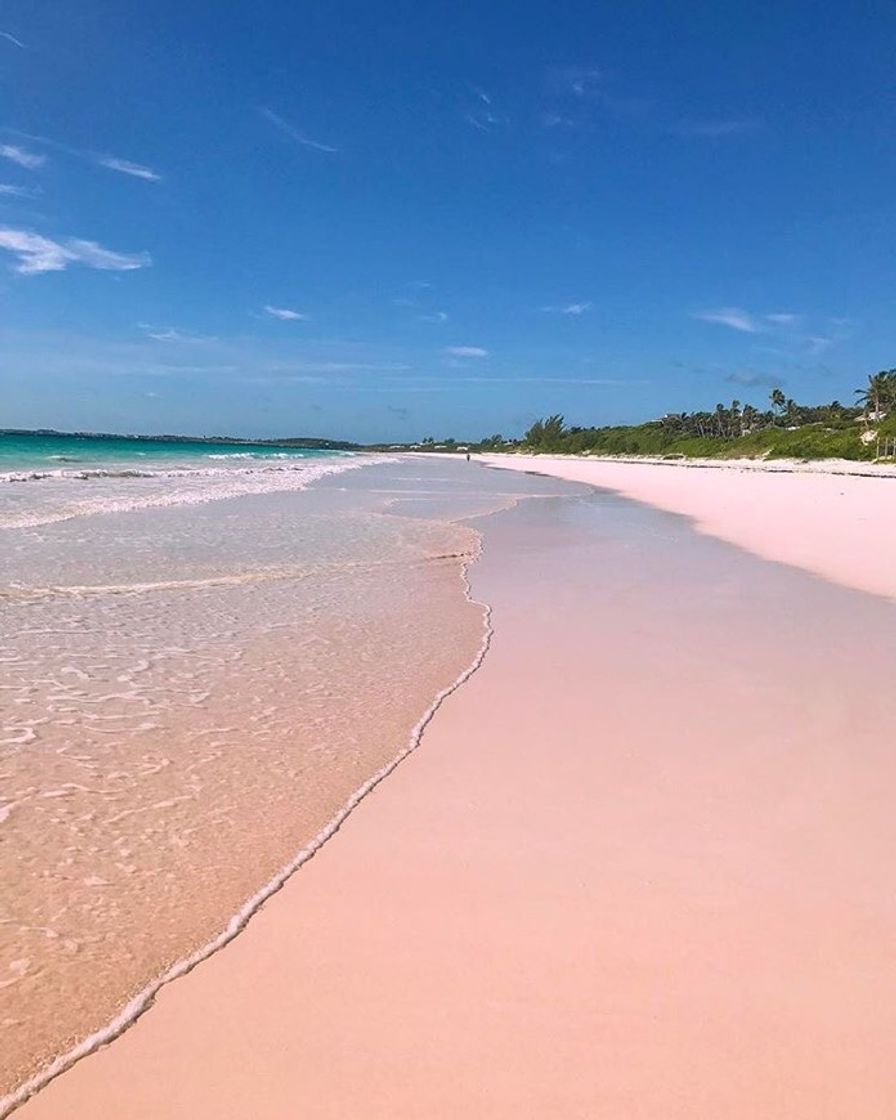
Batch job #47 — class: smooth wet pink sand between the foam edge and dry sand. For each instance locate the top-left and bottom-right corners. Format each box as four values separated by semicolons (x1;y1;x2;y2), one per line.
20;477;896;1120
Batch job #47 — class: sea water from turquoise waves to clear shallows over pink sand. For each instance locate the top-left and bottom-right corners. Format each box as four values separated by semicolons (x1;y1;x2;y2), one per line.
0;450;571;1096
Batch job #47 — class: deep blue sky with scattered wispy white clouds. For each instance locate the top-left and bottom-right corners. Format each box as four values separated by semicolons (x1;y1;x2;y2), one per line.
0;0;896;439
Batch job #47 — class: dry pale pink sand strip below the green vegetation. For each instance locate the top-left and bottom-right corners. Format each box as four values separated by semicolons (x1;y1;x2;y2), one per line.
477;455;896;598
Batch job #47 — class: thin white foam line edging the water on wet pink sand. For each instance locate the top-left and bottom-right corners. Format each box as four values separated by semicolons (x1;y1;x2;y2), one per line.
0;533;494;1120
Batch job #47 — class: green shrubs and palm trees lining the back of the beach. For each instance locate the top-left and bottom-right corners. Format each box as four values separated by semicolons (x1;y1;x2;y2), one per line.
389;370;896;461
